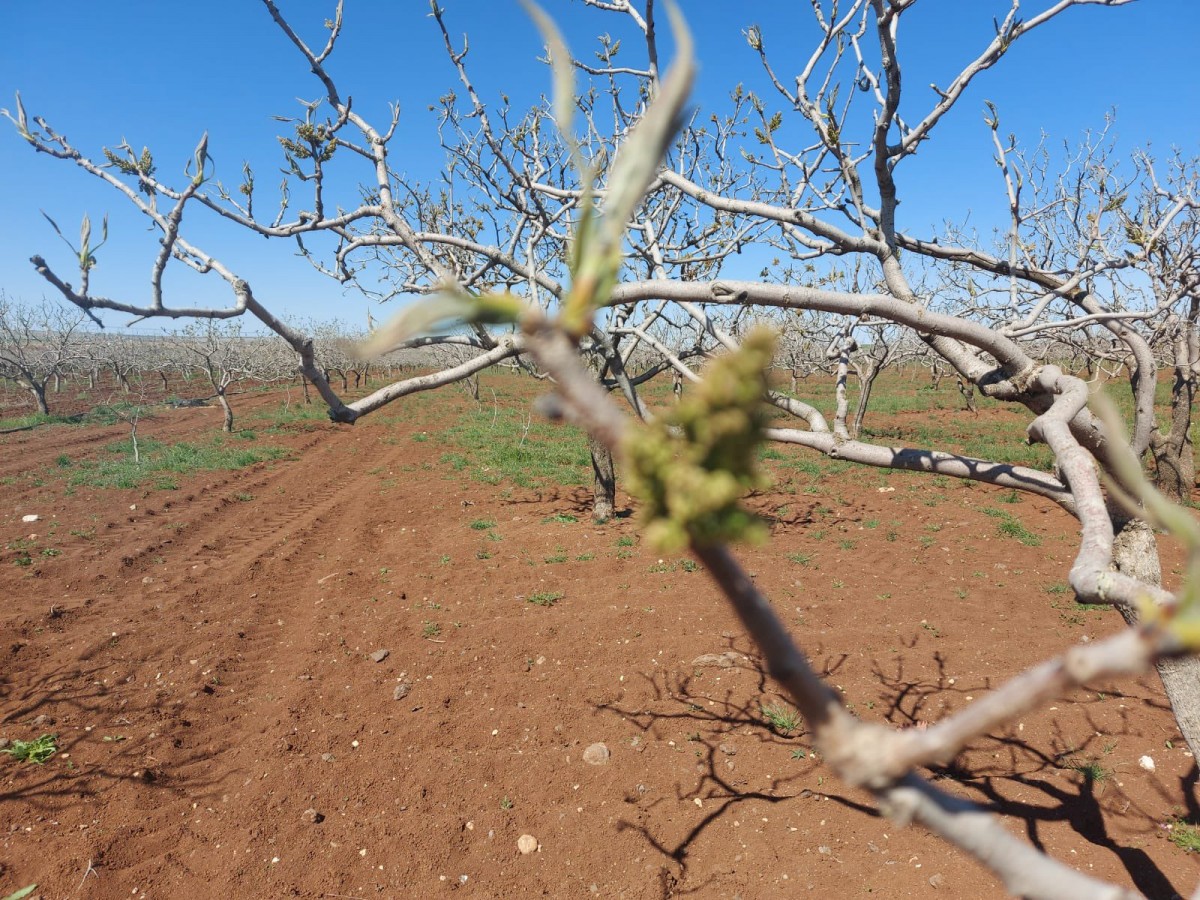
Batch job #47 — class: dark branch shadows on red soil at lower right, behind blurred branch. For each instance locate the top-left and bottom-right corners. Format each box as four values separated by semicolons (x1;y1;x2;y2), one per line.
598;638;1200;898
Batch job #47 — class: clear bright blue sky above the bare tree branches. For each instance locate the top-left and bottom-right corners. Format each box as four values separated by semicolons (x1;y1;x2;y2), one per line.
0;0;1200;325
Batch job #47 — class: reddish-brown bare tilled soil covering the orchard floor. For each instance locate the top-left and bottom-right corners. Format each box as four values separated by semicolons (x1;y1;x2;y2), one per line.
0;383;1200;899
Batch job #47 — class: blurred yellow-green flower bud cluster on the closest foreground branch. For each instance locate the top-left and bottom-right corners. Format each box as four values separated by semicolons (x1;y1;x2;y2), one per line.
623;329;775;552
